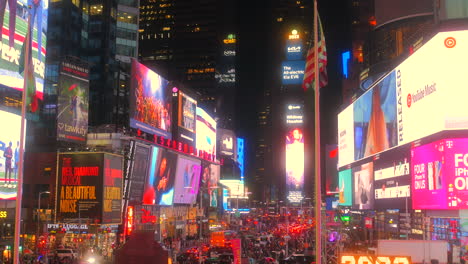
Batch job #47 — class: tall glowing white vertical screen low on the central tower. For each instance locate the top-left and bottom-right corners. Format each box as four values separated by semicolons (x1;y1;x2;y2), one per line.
285;128;304;203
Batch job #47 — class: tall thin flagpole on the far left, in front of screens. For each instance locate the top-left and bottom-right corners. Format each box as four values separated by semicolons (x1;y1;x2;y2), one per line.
13;12;31;264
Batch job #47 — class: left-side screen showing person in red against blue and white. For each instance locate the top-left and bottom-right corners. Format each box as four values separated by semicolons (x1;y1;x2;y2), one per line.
153;150;177;205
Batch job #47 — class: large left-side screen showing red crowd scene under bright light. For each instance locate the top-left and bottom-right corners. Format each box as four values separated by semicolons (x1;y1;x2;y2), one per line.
130;59;172;138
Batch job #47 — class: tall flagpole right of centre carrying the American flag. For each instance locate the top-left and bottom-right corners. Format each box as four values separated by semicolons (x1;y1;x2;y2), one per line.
314;0;322;264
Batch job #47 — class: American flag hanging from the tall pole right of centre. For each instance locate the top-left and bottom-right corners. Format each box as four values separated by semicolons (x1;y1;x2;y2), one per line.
302;18;328;91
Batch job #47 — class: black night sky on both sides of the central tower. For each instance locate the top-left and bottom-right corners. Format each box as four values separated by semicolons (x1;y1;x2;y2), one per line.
236;0;350;178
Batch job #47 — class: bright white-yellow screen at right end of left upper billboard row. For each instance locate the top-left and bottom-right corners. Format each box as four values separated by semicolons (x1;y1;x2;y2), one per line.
196;107;216;160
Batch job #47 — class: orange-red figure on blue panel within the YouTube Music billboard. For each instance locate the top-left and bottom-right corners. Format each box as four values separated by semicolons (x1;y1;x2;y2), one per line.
353;71;398;160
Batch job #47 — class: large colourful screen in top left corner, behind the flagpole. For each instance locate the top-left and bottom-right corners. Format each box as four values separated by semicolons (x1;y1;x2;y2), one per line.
0;0;49;103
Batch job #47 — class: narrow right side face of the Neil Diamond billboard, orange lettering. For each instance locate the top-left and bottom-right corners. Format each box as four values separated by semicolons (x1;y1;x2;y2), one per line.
102;154;123;224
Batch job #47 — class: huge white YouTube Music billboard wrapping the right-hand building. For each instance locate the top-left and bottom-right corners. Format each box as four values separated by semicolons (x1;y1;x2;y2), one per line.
338;31;468;167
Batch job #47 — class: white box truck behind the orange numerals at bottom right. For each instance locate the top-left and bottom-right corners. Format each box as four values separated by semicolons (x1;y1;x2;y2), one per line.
375;240;449;264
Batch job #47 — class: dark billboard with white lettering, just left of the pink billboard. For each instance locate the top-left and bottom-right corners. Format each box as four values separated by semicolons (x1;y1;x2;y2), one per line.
374;146;411;209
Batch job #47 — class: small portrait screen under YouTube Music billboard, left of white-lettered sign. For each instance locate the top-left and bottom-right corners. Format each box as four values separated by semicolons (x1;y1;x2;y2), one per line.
352;162;375;209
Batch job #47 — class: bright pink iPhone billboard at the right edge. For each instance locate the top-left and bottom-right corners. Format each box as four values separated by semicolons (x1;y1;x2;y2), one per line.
411;138;468;209
